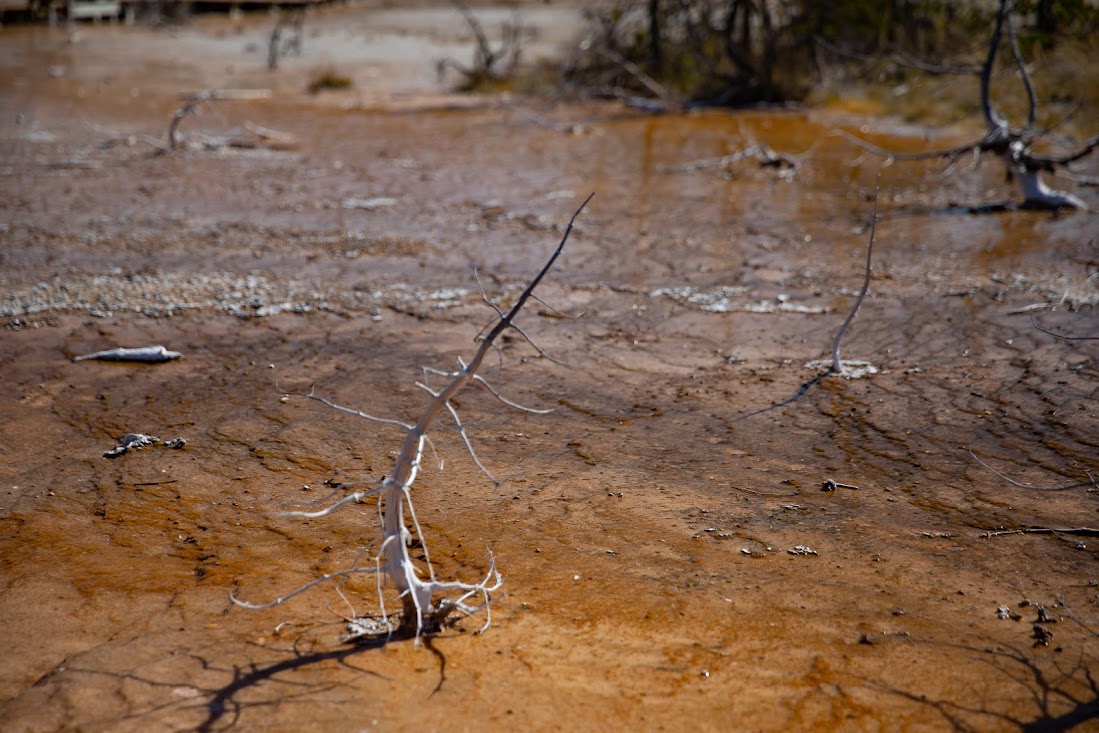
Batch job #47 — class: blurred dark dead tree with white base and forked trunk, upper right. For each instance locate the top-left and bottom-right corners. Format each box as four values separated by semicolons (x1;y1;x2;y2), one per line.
847;0;1099;210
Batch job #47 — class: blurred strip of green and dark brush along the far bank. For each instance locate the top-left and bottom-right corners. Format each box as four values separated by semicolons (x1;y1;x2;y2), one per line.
567;0;1099;105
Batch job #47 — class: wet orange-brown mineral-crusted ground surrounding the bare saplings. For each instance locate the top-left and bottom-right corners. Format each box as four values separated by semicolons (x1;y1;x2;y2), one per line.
0;5;1099;731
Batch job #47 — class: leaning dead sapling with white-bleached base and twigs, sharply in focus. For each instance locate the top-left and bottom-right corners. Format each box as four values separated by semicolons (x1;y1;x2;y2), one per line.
232;195;593;637
